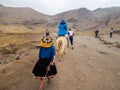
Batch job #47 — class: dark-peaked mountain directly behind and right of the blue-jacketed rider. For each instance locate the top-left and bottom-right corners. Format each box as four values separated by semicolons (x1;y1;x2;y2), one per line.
53;8;98;30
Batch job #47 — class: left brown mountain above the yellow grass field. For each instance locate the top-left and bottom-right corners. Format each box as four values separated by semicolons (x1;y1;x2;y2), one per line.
0;7;48;24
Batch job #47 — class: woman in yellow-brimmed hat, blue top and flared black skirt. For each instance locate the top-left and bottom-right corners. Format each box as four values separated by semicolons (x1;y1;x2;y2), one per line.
32;35;57;90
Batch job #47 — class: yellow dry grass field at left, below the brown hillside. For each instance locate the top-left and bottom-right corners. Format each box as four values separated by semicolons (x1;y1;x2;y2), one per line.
0;25;49;47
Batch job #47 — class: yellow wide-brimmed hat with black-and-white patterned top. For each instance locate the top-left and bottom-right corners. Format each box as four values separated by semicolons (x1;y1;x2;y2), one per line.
40;36;54;48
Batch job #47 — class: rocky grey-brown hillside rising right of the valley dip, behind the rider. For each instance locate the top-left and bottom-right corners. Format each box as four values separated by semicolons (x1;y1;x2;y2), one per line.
52;7;120;30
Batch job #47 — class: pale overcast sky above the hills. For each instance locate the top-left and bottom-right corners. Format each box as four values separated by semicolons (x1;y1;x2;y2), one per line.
0;0;120;15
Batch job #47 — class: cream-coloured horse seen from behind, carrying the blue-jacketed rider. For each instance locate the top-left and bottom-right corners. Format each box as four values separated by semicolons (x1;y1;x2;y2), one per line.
56;36;67;61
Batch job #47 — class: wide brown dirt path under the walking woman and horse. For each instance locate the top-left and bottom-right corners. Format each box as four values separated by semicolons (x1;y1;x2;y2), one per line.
0;36;120;90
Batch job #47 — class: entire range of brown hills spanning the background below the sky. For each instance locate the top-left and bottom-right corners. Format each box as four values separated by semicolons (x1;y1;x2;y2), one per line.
0;5;120;30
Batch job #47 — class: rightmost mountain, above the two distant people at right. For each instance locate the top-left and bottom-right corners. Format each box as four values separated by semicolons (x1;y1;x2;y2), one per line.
93;7;120;29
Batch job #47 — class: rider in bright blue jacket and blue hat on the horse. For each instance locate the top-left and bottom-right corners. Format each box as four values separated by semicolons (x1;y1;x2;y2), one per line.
57;19;68;37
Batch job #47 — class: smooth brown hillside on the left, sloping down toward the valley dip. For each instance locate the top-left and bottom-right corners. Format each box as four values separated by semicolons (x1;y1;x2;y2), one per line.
0;7;47;23
